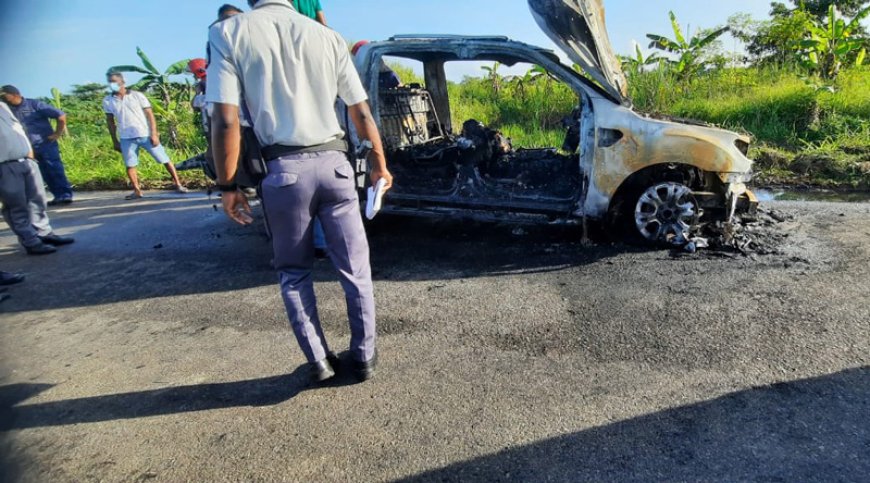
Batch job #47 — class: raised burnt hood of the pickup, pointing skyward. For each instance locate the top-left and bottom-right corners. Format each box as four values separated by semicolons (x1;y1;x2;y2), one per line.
529;0;628;104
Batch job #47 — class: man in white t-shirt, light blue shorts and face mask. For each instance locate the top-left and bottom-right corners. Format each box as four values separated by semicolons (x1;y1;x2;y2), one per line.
103;71;187;200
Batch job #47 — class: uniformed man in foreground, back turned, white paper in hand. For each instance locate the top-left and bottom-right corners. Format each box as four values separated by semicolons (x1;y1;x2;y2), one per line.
206;0;392;382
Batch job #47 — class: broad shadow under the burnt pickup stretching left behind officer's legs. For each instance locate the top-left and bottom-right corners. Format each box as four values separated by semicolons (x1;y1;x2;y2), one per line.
0;195;627;313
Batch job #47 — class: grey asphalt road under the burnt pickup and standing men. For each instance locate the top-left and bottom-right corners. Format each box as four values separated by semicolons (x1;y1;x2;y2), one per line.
0;193;870;482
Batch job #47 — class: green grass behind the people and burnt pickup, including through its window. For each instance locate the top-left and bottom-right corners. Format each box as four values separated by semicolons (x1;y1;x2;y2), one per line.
60;63;870;189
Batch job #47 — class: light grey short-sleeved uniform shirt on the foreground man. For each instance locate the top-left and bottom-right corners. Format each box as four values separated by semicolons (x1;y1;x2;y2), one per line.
206;0;368;147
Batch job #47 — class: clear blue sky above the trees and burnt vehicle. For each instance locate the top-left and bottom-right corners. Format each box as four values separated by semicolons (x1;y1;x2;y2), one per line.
0;0;769;97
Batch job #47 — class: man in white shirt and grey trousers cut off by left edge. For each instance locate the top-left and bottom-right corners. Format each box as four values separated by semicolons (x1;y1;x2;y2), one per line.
0;102;73;255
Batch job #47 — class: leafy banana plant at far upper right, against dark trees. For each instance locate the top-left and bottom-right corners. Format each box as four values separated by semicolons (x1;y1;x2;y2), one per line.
797;4;870;80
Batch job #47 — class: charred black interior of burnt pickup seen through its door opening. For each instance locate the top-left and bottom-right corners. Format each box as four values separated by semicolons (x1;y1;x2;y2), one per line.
370;48;582;215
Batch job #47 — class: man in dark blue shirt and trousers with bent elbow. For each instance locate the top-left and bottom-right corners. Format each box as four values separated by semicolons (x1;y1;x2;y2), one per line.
0;86;73;206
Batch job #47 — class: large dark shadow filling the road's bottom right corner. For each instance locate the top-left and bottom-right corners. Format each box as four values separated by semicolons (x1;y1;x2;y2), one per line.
404;366;870;482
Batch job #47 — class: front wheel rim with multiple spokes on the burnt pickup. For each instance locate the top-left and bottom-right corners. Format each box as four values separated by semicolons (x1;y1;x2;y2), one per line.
633;182;700;245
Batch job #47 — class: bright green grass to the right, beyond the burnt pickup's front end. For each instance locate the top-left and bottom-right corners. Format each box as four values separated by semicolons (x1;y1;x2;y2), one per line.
630;67;870;189
